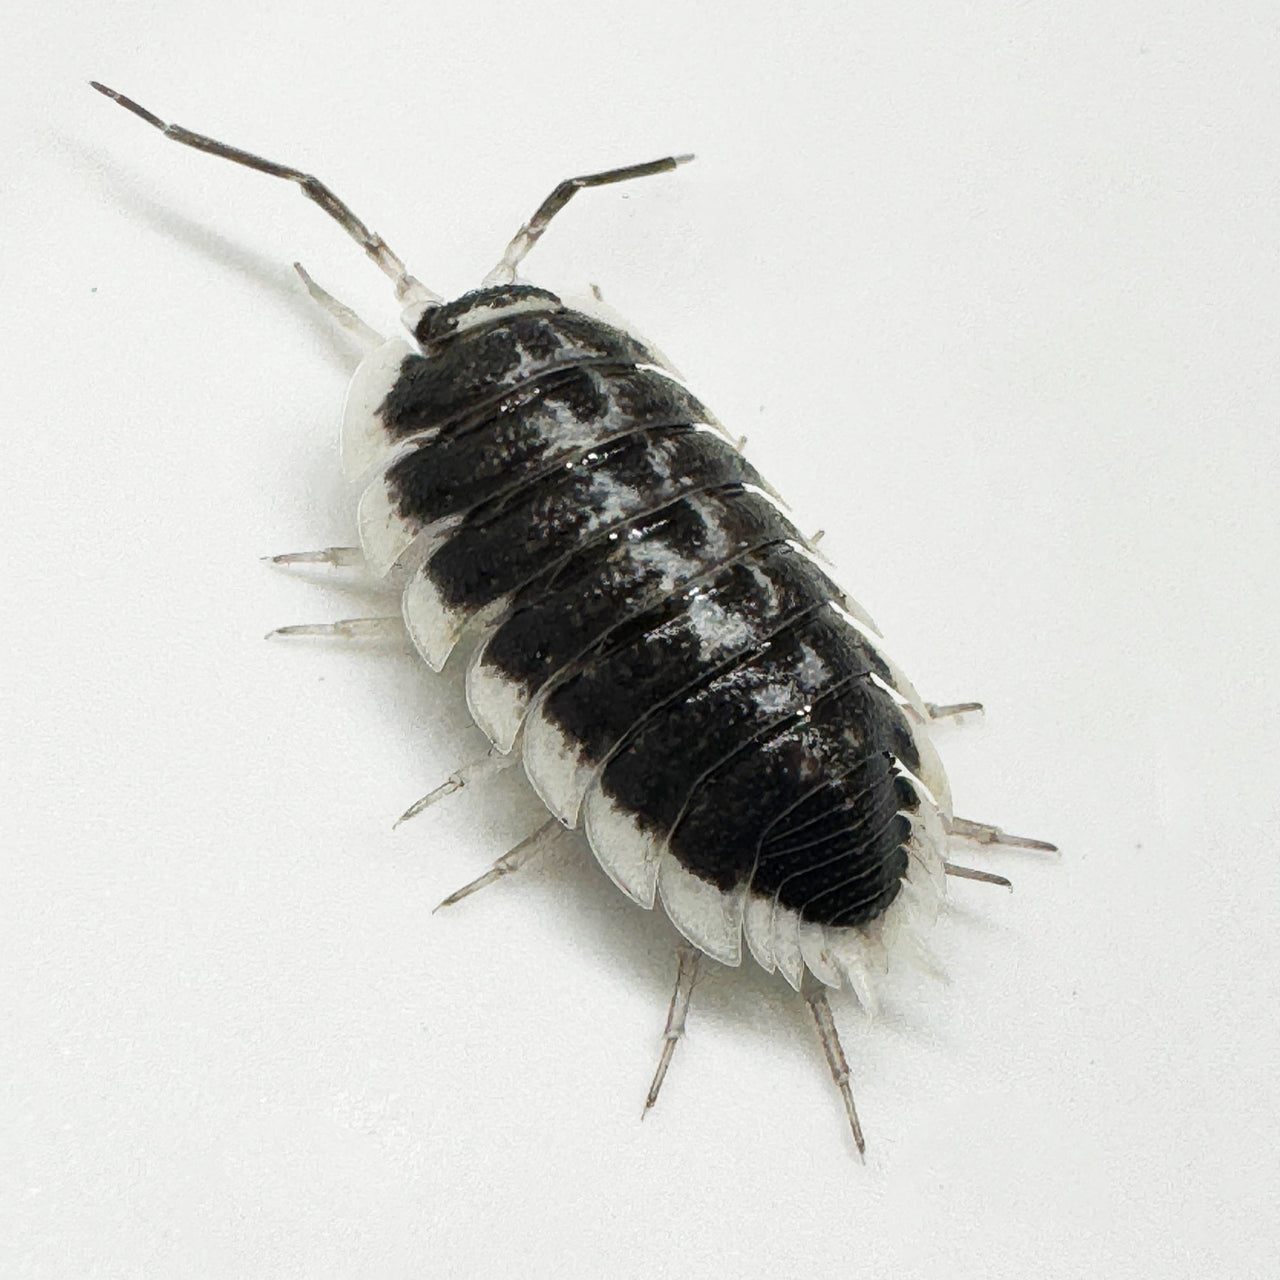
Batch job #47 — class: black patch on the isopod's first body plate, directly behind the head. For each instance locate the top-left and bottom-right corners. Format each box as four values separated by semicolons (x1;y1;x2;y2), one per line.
378;311;655;440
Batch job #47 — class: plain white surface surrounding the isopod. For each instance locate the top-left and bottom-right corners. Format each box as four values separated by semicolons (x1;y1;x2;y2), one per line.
0;0;1280;1280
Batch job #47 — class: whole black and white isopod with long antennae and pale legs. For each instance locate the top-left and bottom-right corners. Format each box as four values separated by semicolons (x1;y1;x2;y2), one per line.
93;83;1053;1151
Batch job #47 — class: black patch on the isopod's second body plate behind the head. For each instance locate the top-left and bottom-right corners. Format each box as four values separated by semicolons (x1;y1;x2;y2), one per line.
384;367;709;527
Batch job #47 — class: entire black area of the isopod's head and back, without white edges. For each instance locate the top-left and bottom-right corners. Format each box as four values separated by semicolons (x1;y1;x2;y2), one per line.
379;285;936;925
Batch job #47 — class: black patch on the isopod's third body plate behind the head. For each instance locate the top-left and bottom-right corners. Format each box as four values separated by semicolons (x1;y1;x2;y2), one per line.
421;429;759;612
